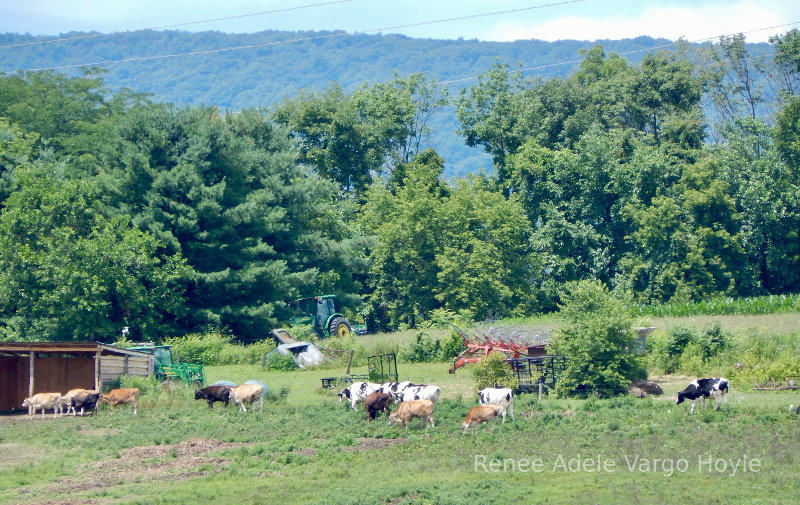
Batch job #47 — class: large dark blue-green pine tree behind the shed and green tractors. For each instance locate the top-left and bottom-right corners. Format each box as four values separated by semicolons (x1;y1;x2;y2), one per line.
99;105;366;339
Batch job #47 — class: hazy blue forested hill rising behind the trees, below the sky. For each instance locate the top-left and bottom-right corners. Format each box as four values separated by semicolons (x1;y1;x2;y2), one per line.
0;30;688;175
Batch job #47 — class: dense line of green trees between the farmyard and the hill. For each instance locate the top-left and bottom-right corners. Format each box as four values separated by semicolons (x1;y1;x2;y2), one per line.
0;30;800;340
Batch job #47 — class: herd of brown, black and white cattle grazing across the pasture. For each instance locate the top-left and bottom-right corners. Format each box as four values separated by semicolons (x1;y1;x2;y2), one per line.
22;378;728;433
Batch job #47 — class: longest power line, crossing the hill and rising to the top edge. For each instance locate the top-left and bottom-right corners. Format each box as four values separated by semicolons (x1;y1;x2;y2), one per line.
6;0;589;72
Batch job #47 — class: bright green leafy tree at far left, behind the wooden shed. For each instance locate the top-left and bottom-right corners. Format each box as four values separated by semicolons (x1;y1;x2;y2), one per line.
0;164;187;340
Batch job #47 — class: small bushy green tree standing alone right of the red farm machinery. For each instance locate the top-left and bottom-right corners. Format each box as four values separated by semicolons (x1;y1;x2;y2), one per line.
550;281;645;396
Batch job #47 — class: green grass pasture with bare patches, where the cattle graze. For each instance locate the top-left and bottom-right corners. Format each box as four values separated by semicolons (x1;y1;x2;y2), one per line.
0;316;800;505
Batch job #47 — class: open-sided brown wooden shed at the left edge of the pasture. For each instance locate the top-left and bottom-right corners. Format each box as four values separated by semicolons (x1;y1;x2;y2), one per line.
0;342;154;411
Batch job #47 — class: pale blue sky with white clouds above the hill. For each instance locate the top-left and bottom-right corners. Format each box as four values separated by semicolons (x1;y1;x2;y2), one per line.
0;0;800;42
